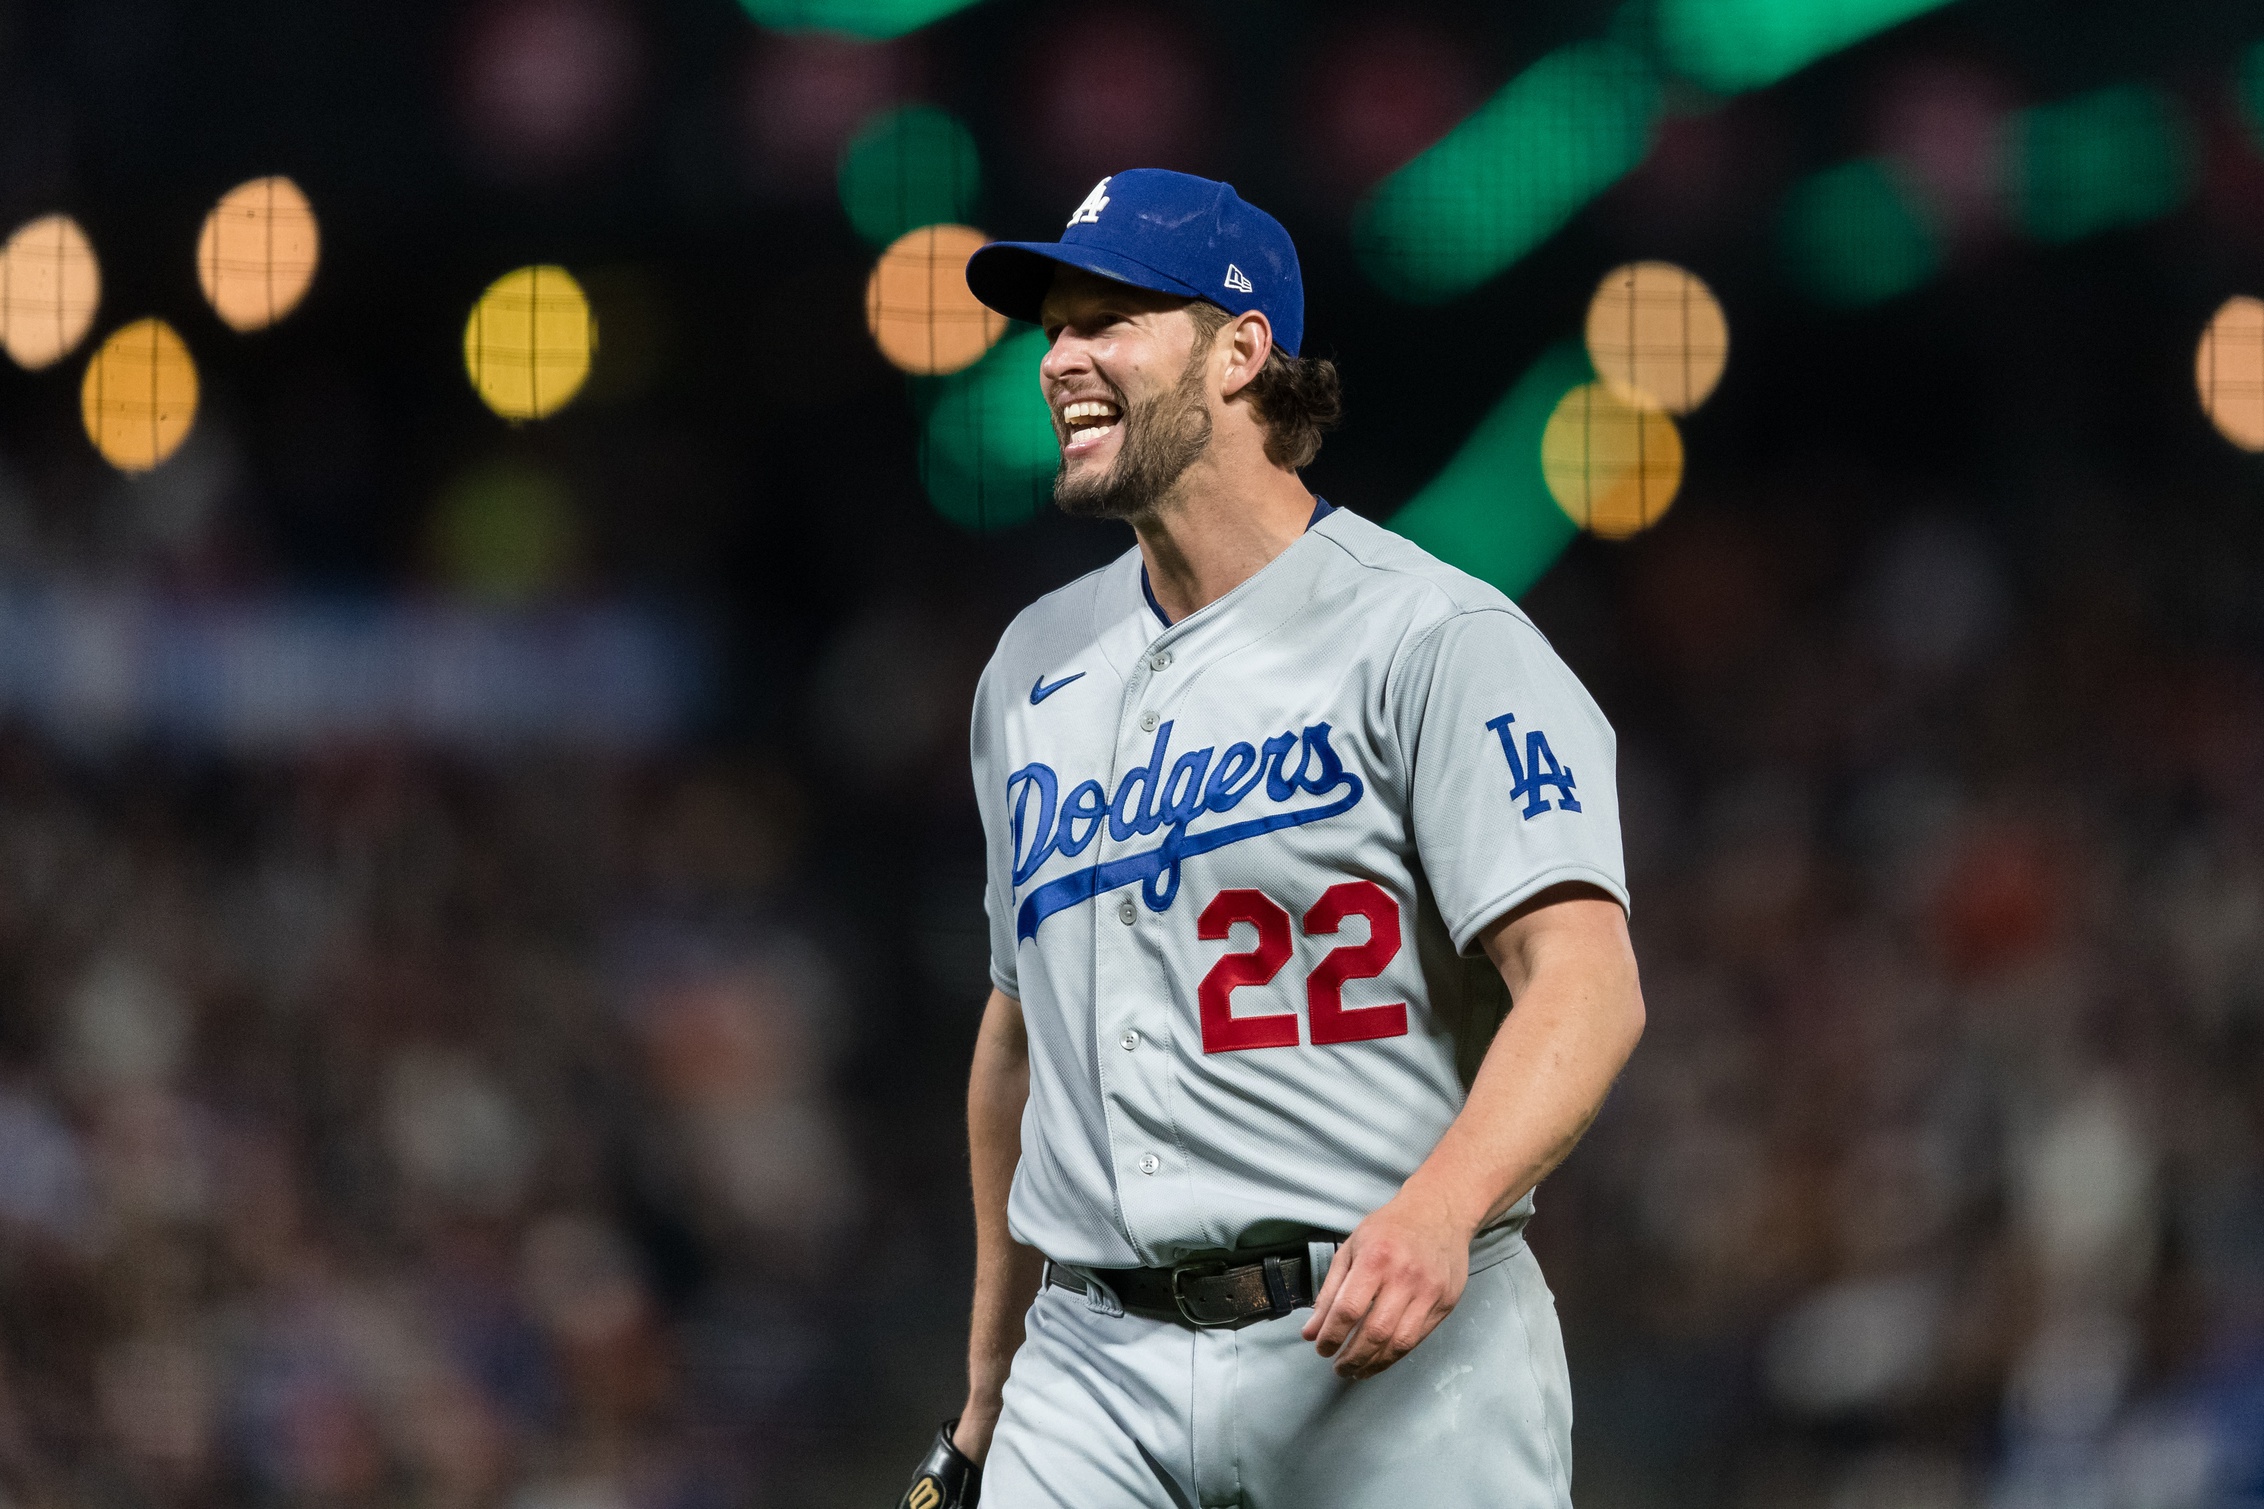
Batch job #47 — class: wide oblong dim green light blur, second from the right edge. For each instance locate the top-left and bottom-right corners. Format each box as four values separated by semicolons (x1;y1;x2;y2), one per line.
2008;84;2194;242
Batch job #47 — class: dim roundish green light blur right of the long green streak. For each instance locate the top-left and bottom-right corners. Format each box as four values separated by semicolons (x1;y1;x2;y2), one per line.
1777;158;1943;308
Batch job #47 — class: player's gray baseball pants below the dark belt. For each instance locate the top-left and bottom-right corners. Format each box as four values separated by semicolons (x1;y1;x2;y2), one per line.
983;1231;1571;1509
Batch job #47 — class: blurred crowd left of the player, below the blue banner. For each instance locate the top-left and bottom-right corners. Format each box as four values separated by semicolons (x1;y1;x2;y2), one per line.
0;740;876;1507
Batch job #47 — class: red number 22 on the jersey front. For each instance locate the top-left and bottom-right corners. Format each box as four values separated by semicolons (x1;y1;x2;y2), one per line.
1195;880;1408;1054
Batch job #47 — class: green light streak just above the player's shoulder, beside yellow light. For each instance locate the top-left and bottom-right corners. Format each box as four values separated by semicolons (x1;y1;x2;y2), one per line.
1390;342;1596;597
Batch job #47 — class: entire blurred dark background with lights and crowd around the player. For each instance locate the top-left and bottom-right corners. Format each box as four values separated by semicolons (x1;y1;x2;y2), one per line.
0;0;2264;1509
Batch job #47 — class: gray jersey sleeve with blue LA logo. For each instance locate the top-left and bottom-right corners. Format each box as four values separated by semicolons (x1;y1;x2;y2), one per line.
1392;609;1628;952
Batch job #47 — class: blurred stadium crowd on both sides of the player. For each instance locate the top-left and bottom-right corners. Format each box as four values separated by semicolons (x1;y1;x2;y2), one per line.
0;475;2264;1509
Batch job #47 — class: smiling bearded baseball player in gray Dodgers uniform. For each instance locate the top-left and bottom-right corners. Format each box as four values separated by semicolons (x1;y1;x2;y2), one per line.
903;170;1644;1509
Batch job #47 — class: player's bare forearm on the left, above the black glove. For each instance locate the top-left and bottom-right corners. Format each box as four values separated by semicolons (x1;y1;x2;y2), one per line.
955;991;1041;1461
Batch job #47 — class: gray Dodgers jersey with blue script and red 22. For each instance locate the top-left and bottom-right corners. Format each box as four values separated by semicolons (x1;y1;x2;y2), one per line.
974;511;1628;1267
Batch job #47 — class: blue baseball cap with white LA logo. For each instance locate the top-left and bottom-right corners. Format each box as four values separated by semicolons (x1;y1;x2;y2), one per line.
967;167;1304;355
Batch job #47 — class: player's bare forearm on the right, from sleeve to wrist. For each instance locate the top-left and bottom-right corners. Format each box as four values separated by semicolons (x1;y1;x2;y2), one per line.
1406;900;1644;1231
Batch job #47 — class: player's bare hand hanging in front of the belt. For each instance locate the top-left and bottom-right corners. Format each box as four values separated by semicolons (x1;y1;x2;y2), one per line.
1304;1185;1472;1378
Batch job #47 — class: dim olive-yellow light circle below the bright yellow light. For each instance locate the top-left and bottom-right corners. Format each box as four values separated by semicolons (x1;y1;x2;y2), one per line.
430;459;580;606
